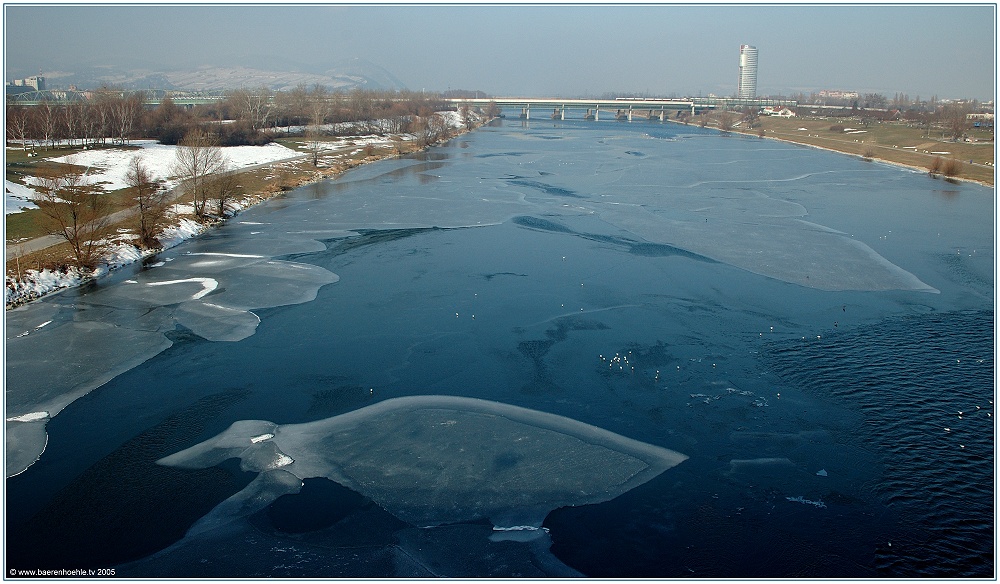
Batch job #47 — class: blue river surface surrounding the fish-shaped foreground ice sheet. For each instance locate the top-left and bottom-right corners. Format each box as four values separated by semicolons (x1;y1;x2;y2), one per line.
5;116;995;578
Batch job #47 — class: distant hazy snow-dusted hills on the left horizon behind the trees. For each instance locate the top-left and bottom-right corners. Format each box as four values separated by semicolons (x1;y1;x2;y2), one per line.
7;59;407;92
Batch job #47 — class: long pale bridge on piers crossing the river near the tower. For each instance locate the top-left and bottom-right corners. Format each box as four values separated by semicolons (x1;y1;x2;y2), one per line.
444;97;798;121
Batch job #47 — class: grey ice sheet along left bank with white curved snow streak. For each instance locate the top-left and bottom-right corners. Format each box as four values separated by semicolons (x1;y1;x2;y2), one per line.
6;244;339;476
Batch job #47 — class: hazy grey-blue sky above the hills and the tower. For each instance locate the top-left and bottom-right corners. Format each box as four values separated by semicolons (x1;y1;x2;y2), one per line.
4;4;996;100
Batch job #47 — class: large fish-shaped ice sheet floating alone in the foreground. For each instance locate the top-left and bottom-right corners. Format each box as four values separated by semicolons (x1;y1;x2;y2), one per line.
159;396;687;536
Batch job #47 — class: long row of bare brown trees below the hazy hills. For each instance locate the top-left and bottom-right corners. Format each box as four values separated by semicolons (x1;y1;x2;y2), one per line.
7;85;476;149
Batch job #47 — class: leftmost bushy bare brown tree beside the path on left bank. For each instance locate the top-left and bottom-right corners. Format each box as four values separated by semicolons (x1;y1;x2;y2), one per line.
35;172;111;268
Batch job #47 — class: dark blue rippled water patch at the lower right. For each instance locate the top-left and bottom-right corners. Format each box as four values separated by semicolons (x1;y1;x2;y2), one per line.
769;311;996;578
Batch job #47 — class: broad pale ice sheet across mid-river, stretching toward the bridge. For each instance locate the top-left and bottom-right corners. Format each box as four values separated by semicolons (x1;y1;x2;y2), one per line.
272;132;936;292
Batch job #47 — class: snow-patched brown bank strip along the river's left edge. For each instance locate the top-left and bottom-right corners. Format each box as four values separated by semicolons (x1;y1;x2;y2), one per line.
4;112;488;310
